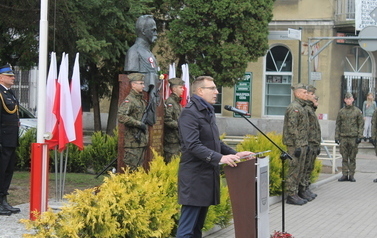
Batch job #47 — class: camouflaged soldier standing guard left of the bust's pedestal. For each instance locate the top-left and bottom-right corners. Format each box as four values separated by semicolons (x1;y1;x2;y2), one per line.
118;73;148;171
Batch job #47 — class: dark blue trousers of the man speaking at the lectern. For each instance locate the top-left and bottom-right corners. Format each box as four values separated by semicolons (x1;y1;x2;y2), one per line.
177;205;208;238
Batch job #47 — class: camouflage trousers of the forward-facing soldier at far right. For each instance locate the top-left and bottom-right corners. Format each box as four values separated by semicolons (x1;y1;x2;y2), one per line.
339;137;359;176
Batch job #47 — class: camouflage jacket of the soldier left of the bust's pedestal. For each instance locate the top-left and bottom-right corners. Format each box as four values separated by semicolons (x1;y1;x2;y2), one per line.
118;90;148;147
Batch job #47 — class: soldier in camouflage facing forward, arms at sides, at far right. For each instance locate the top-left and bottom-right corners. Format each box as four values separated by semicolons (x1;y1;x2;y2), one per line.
335;93;364;182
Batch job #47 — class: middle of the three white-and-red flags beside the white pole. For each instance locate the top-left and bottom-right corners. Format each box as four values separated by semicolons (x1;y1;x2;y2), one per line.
54;53;76;151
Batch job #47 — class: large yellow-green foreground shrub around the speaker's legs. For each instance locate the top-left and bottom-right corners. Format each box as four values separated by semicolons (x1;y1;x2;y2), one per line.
22;153;231;238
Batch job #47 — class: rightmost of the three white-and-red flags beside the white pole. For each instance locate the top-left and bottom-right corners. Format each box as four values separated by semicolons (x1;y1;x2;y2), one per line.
71;53;84;150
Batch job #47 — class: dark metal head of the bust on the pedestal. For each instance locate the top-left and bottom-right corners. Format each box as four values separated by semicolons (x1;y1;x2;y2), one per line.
136;15;157;44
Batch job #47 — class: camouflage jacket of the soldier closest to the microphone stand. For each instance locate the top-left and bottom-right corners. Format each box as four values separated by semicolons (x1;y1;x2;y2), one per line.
283;98;309;148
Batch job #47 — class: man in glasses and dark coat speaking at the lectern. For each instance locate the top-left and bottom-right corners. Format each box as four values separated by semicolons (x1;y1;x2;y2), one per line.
177;76;252;238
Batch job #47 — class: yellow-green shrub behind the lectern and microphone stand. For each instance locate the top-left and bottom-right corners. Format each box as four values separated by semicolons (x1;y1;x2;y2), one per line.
237;132;321;196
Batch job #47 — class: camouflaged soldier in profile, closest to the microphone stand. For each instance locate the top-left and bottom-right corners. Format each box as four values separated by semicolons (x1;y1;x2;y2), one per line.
283;83;309;205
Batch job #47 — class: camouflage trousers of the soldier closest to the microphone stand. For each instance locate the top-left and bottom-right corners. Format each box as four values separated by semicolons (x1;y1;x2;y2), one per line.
285;146;307;196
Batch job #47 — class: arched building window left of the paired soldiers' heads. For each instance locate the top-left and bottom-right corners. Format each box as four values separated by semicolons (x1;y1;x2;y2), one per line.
264;46;292;116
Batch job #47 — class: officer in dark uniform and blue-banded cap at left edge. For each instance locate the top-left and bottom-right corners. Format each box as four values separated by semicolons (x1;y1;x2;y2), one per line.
0;64;20;216
